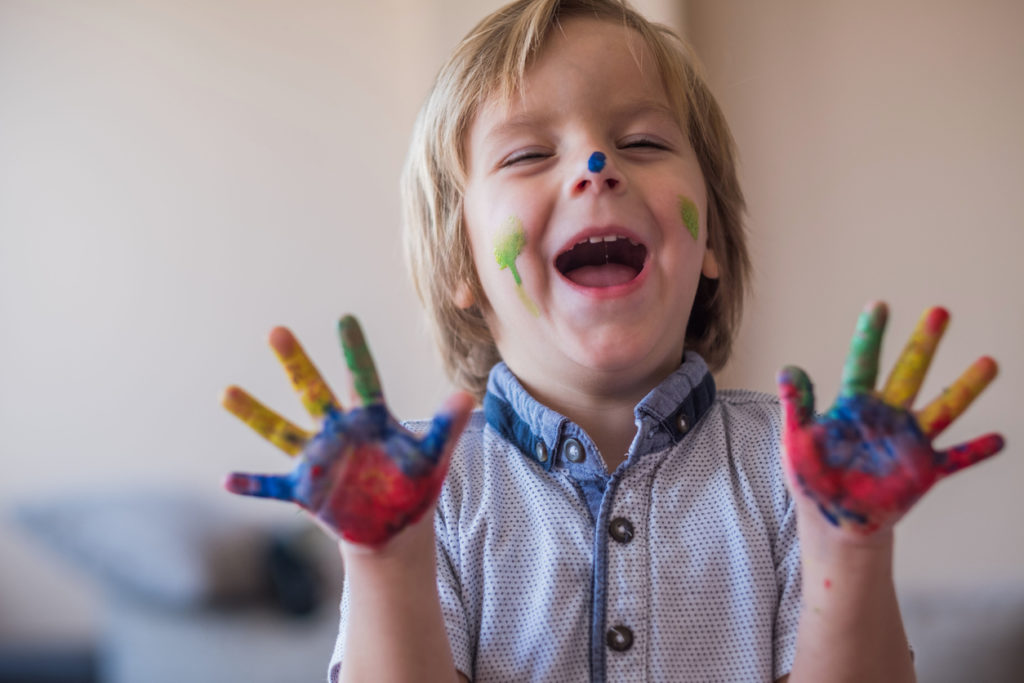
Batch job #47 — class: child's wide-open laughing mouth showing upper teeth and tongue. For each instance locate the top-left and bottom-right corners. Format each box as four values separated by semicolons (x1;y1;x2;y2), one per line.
555;234;647;287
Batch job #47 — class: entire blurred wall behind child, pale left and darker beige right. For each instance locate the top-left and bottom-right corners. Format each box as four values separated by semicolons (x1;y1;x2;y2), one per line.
0;0;1024;642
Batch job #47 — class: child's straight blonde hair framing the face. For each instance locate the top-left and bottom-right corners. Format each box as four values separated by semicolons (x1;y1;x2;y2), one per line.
402;0;751;398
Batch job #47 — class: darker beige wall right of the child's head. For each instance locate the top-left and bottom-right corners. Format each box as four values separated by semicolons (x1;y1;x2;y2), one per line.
688;0;1024;585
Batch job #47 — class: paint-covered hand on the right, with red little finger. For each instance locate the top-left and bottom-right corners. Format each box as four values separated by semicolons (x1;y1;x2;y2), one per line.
778;302;1002;535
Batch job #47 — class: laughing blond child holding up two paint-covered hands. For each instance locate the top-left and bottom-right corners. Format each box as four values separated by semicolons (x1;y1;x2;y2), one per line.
225;0;999;683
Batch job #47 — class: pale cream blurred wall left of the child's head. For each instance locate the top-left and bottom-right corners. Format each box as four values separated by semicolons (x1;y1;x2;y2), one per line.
0;0;676;644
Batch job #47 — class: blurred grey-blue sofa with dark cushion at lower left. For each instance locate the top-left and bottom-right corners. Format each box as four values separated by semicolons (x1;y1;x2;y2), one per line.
9;490;342;683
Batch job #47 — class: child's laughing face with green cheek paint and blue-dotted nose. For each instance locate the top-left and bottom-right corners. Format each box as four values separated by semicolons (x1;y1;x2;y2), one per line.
457;18;717;391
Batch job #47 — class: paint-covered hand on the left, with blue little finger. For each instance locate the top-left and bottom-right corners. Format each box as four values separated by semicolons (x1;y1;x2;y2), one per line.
221;315;473;547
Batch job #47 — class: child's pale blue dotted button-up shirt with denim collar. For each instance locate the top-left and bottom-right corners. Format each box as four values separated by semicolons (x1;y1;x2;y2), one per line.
330;352;800;682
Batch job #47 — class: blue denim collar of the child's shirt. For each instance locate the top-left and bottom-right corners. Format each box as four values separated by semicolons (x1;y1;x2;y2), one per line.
483;351;715;470
